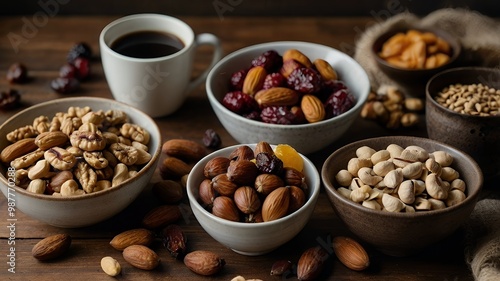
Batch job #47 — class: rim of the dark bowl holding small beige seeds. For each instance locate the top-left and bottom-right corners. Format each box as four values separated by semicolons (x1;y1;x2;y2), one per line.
425;66;500;120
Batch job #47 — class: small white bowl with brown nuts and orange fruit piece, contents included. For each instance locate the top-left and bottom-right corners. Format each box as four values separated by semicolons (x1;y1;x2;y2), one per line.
187;142;320;256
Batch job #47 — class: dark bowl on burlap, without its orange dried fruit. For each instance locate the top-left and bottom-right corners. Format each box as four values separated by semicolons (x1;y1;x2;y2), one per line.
372;27;462;97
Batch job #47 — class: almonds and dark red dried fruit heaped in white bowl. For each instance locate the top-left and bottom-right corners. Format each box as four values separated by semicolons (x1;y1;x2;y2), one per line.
222;49;355;125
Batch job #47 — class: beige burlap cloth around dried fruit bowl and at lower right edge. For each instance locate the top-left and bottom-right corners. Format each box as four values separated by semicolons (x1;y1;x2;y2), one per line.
354;8;500;281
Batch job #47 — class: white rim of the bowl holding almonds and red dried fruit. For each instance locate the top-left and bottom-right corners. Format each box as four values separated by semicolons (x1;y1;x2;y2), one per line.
205;41;370;129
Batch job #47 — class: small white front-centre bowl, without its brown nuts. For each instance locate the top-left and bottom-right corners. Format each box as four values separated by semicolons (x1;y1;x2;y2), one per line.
187;144;320;256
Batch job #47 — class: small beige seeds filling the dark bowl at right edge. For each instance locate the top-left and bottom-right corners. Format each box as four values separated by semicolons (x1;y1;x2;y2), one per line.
435;83;500;116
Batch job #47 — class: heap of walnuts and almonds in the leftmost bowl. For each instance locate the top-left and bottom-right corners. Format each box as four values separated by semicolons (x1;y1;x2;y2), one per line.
0;107;151;196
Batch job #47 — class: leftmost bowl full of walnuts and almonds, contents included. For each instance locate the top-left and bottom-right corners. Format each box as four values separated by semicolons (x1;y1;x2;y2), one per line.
0;97;161;228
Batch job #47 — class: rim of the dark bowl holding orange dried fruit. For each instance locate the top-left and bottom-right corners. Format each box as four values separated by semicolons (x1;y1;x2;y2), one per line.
370;26;462;74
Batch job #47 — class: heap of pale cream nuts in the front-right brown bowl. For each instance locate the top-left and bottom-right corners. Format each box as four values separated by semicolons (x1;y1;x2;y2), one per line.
335;144;466;212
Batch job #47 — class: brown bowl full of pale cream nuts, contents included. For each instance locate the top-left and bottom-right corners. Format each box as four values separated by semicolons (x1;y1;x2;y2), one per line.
321;136;483;256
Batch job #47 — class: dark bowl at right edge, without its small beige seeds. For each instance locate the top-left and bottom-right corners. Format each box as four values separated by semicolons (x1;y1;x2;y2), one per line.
425;67;500;181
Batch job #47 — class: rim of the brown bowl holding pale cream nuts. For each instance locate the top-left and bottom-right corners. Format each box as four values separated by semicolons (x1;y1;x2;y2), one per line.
321;136;484;219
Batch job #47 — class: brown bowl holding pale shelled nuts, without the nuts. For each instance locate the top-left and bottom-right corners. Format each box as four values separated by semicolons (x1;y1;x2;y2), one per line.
321;136;483;256
